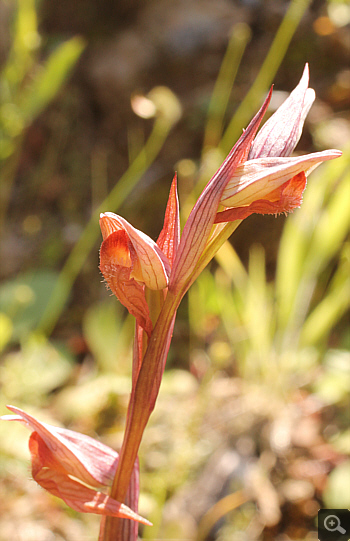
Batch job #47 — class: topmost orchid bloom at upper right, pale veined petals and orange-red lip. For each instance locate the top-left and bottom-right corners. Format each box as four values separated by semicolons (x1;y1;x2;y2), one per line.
215;65;341;223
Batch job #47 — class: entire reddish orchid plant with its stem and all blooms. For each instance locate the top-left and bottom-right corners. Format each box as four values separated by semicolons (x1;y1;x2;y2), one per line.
1;65;341;541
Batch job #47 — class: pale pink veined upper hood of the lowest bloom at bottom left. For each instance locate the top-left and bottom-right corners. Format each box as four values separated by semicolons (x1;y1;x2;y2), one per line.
1;406;118;487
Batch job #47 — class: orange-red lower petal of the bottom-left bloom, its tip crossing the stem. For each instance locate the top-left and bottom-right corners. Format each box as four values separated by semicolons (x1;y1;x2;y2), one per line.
29;432;151;525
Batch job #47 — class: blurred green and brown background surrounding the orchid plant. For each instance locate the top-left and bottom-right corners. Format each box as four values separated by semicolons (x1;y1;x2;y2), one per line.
0;0;350;541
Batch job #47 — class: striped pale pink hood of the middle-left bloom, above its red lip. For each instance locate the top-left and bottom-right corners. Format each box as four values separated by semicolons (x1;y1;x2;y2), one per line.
100;212;170;290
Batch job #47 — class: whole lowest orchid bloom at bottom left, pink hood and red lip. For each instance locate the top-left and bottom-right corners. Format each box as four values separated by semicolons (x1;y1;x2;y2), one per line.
0;406;150;525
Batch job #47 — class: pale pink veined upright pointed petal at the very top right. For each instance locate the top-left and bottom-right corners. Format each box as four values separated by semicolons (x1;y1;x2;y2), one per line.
248;64;315;160
